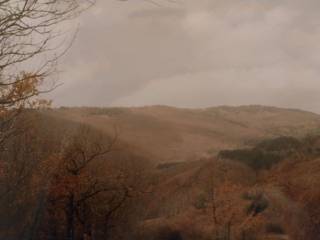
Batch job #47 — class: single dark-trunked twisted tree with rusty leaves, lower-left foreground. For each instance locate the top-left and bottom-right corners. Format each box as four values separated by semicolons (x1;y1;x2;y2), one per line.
49;127;122;240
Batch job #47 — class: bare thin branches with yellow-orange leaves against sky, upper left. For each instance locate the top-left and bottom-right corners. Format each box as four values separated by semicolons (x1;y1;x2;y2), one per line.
0;0;93;146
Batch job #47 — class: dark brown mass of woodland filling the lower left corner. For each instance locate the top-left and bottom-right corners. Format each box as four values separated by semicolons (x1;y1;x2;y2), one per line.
0;111;147;240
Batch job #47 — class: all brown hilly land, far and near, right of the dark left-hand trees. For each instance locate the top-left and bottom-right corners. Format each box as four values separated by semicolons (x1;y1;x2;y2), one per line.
33;106;320;240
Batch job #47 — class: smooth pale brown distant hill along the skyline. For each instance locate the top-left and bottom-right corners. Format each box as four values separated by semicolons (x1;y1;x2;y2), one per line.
46;106;320;162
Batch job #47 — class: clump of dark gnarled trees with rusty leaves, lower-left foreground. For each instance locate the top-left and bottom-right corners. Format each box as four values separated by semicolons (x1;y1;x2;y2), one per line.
41;127;150;240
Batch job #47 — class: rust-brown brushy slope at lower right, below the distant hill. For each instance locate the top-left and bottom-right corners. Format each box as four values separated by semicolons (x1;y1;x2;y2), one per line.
136;136;320;240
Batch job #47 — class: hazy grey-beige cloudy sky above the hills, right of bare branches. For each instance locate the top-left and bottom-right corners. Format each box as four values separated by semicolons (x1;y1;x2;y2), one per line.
48;0;320;112
